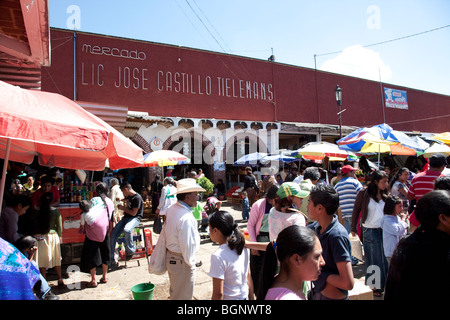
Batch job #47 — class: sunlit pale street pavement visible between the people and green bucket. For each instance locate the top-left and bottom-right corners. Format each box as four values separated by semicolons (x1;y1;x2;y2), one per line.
49;202;372;300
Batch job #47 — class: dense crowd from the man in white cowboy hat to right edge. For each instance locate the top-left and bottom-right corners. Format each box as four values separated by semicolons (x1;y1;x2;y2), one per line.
141;154;450;300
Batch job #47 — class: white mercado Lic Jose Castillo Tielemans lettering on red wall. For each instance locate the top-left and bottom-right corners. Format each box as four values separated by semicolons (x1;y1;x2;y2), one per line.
78;44;274;101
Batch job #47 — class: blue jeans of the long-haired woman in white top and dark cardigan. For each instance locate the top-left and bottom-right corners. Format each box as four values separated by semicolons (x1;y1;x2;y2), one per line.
362;227;388;291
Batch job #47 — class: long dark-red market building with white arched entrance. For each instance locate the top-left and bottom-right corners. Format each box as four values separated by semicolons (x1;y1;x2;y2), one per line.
23;28;450;186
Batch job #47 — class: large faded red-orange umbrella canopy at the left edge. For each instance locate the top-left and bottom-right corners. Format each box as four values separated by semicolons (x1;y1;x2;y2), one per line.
0;81;144;171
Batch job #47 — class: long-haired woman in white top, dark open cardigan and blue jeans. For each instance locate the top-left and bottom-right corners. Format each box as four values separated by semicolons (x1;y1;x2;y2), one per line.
351;170;389;297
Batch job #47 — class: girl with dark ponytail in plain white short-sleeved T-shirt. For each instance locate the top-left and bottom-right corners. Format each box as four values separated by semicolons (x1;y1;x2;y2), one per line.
209;211;254;300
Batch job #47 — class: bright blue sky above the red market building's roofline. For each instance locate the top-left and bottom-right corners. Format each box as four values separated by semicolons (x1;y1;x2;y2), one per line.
49;0;450;95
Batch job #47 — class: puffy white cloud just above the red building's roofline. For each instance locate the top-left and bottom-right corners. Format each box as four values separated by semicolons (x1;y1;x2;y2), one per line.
319;45;392;82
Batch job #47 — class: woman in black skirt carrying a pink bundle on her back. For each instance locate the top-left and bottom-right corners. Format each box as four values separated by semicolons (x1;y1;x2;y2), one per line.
80;182;114;288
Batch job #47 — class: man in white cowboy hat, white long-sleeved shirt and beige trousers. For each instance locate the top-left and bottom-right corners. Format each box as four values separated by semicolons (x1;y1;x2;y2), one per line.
165;178;205;300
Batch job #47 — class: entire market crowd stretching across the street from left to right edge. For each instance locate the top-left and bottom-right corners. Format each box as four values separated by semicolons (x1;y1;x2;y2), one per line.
0;154;450;300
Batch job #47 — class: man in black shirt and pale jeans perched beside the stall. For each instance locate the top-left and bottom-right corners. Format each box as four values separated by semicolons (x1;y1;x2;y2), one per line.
111;181;144;261
